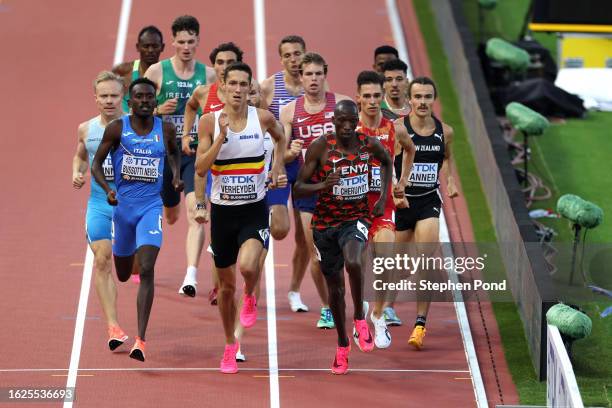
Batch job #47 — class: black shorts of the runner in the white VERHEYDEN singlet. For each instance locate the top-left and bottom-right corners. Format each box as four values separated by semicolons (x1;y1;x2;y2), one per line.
210;199;270;268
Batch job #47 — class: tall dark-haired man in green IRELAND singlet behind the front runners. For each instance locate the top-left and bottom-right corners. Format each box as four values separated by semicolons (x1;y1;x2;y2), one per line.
145;16;215;297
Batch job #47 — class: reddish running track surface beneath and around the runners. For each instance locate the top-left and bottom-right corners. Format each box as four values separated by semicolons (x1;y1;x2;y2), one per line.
0;0;516;407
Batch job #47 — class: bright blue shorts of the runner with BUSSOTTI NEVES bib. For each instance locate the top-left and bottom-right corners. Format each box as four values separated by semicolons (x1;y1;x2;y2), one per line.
112;195;163;256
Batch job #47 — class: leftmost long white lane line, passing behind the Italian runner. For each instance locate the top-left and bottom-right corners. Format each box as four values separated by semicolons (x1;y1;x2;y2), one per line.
64;0;132;408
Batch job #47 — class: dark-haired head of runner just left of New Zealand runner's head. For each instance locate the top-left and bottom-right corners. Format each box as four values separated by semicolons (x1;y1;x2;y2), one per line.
381;59;410;117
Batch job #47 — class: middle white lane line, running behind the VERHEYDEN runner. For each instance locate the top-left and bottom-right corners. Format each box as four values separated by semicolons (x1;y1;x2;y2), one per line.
253;0;280;408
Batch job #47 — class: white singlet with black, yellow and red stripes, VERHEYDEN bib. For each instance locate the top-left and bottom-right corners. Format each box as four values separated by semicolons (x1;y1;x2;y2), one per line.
210;106;266;206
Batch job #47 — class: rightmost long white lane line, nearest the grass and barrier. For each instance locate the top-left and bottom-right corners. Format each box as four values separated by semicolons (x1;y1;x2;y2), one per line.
386;0;488;408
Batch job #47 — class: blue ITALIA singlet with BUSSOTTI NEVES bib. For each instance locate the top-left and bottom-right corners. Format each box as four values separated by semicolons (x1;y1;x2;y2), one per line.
111;115;166;198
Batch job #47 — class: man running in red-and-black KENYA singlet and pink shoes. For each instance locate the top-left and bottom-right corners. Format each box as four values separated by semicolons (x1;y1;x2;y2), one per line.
293;100;392;374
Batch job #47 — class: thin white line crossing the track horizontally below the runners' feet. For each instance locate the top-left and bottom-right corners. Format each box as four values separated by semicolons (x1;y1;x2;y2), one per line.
0;367;470;374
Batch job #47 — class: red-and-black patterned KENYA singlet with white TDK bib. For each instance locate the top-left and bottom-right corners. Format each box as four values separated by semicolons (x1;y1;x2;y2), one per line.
312;133;370;231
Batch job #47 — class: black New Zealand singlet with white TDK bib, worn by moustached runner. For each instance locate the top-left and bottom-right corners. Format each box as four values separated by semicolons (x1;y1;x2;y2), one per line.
394;117;445;197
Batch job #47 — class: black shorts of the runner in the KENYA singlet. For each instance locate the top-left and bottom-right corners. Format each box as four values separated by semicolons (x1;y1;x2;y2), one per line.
312;220;370;276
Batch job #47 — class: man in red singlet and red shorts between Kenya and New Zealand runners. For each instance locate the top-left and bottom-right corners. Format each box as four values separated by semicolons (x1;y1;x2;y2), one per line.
357;71;415;348
